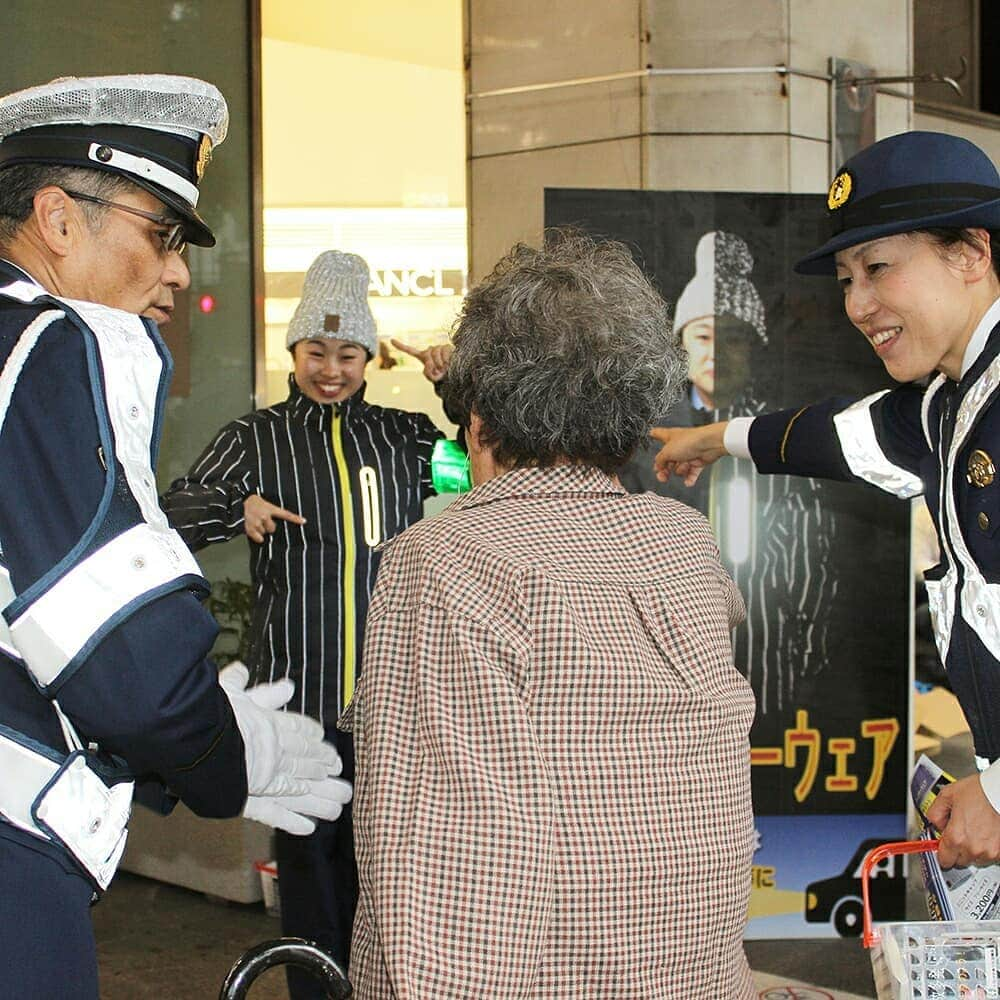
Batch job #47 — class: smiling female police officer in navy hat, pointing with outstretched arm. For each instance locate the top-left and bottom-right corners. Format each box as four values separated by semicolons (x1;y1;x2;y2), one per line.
656;132;1000;867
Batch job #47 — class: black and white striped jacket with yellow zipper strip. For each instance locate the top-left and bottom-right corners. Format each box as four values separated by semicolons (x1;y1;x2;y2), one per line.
162;378;442;728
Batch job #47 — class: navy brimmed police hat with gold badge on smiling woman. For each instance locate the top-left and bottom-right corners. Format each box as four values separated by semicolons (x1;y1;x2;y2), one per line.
795;132;1000;274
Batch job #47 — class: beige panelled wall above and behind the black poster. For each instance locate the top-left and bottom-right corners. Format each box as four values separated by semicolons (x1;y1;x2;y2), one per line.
466;0;912;280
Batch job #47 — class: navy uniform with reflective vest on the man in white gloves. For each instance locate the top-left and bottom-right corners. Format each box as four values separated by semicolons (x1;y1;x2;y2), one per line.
0;261;247;998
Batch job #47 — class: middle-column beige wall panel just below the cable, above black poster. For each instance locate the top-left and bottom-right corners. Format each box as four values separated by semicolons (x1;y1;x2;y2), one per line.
645;135;789;192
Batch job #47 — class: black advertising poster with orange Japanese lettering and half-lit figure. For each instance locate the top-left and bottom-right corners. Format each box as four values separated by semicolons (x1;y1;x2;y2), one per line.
545;190;910;938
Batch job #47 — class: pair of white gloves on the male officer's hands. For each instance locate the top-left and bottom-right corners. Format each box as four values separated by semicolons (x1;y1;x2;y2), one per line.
219;662;351;834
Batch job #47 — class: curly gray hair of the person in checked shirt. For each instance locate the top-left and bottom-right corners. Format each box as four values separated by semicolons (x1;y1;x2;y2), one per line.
442;230;687;473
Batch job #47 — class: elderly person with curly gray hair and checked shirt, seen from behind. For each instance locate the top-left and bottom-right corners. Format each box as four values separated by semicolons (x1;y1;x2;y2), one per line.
340;233;754;1000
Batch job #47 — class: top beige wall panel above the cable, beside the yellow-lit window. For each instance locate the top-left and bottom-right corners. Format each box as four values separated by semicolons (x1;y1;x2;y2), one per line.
466;0;641;93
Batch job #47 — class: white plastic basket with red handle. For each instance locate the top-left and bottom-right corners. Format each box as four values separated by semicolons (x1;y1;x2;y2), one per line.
861;840;1000;1000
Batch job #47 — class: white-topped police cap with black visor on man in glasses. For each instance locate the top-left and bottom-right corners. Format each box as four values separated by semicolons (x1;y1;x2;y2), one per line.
0;75;229;247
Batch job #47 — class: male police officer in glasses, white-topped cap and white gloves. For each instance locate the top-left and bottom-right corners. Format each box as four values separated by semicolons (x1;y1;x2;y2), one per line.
0;76;350;1000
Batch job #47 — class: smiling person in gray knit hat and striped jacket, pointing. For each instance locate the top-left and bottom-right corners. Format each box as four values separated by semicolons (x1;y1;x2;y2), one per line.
163;250;448;1000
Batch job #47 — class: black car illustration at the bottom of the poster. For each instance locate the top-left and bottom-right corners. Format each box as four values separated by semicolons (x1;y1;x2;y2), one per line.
805;837;906;937
